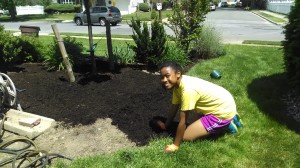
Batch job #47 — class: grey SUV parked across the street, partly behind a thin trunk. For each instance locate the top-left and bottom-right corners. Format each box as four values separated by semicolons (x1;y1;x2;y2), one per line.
74;6;122;26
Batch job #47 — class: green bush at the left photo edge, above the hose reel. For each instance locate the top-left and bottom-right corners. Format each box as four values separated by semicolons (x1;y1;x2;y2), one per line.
0;26;44;63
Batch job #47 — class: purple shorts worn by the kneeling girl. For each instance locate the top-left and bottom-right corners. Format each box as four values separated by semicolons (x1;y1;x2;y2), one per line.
200;114;232;134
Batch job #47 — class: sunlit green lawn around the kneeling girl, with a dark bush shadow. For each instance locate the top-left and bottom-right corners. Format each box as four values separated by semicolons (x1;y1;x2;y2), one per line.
53;45;300;168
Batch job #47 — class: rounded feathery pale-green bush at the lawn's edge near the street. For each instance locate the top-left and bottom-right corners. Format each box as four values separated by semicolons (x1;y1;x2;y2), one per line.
192;26;226;59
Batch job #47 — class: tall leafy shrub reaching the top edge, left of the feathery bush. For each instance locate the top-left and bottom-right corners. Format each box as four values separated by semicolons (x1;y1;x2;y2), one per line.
167;0;209;53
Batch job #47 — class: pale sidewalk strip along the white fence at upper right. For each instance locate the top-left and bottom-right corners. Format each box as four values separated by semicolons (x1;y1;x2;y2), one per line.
251;10;289;26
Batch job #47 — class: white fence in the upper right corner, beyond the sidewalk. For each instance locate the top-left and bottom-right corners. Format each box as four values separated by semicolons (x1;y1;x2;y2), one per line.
267;0;294;14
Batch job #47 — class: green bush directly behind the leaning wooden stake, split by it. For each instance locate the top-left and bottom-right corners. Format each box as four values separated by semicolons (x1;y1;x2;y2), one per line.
44;36;83;70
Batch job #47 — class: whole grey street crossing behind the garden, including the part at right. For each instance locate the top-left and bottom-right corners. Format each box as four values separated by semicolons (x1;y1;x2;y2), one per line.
0;8;284;43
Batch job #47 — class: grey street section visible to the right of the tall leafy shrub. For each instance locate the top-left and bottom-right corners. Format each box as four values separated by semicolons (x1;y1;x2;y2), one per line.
205;8;284;43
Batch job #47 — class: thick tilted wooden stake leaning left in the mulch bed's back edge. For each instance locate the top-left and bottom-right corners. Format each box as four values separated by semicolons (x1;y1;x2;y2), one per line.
51;24;75;82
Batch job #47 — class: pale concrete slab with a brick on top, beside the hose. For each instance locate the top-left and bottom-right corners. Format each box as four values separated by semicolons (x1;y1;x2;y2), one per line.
0;109;56;139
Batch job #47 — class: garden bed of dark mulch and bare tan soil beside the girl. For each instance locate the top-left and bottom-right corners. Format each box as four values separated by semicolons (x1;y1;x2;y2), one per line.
0;63;177;157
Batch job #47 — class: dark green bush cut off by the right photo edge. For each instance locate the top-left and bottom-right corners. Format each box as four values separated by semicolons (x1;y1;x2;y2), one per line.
283;0;300;88
